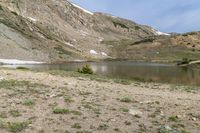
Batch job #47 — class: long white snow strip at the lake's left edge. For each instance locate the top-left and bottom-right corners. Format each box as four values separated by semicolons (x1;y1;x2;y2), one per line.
0;59;44;65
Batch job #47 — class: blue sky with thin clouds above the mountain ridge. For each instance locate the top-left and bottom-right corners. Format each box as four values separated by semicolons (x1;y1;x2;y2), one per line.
71;0;200;33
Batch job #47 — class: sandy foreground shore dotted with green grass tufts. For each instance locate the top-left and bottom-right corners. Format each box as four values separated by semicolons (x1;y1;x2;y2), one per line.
0;69;200;133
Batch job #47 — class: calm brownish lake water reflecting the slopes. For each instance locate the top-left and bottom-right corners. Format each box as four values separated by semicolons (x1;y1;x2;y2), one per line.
1;61;200;85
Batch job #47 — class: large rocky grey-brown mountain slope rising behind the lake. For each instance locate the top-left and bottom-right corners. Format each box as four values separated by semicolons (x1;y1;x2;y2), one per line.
0;0;199;62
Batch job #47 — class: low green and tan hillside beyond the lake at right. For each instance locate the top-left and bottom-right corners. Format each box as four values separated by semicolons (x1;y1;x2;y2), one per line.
111;32;200;62
